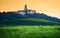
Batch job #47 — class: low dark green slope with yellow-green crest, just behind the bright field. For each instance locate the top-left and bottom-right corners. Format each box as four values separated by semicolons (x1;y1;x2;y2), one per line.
1;18;58;25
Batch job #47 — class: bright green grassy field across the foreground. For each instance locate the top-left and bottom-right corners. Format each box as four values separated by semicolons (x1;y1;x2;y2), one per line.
0;25;60;38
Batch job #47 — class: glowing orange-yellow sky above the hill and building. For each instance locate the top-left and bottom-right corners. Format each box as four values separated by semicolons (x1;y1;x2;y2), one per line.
0;0;60;18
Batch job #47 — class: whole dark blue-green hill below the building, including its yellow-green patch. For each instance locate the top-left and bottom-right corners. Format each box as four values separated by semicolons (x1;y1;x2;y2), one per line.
0;12;60;25
